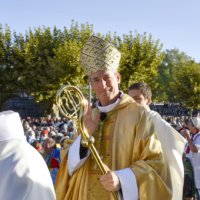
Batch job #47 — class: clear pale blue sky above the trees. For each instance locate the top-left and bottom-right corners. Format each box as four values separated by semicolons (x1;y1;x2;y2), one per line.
0;0;200;62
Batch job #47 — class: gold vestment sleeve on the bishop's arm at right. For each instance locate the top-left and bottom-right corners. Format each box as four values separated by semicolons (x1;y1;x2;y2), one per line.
130;110;172;200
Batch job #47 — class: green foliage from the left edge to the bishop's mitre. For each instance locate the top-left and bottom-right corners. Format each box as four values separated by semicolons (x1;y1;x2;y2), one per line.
0;21;93;111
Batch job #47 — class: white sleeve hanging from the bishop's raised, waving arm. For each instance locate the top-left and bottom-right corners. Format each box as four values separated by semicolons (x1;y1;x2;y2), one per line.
68;135;90;176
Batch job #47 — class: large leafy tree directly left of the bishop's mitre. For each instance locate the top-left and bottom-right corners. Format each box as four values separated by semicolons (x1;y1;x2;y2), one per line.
16;22;92;112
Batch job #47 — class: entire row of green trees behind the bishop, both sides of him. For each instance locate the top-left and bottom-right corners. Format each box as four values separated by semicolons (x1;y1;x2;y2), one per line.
0;20;200;112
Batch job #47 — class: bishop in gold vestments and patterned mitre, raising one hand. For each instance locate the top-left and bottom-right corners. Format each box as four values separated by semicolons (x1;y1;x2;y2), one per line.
55;36;172;200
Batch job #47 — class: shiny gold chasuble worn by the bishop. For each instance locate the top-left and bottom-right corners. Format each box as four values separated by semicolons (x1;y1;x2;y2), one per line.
55;94;172;200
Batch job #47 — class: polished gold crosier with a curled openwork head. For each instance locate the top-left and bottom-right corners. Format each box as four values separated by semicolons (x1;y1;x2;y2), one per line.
56;85;118;200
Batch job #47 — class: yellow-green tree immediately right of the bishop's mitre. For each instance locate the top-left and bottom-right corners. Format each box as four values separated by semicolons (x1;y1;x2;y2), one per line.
118;33;163;96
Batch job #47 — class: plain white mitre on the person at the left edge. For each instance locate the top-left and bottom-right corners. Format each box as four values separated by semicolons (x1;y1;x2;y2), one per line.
0;110;25;141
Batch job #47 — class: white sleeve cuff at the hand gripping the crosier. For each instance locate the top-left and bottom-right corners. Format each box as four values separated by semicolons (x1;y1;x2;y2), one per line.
115;168;139;200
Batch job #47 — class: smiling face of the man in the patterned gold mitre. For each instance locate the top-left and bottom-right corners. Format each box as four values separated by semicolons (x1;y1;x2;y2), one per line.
90;70;120;106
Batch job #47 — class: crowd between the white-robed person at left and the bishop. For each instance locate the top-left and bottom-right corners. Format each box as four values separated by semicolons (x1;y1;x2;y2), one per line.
21;115;75;184
